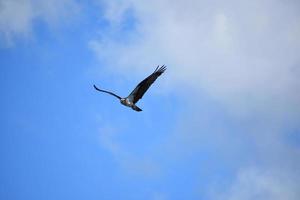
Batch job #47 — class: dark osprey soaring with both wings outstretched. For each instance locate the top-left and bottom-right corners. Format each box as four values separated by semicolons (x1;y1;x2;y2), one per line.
94;65;167;112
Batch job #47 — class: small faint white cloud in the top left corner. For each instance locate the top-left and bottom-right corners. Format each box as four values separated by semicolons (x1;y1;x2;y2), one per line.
0;0;79;46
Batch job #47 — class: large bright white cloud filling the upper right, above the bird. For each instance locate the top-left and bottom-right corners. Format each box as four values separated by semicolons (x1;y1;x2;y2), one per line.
91;0;300;117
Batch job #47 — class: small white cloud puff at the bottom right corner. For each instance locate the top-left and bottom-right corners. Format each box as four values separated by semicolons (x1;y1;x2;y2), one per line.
214;169;300;200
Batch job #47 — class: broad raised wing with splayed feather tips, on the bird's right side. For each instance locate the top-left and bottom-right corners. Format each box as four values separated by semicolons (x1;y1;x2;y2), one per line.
128;65;167;104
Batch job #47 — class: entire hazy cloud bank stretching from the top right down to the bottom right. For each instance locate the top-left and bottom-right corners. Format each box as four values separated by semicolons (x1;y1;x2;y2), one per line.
91;0;300;199
